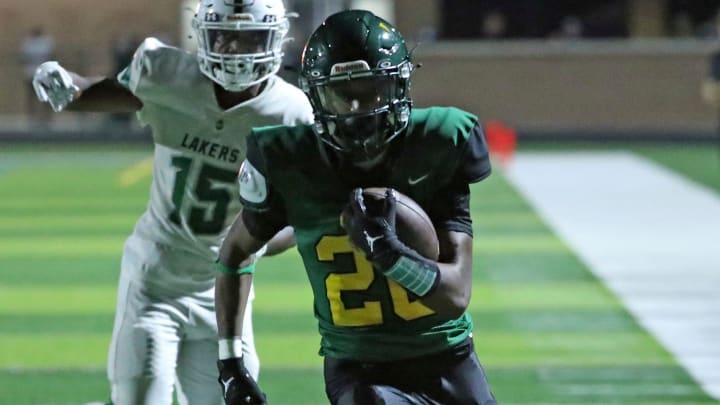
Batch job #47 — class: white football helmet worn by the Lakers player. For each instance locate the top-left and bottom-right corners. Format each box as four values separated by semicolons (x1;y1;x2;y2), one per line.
192;0;290;91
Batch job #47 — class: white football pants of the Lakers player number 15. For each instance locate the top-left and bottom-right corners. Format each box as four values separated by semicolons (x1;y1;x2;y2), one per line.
108;237;260;405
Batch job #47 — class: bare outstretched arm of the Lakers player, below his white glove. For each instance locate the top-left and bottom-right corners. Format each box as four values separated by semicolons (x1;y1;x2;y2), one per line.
67;73;142;112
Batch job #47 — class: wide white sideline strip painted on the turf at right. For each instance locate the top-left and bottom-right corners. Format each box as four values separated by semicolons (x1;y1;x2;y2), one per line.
506;152;720;399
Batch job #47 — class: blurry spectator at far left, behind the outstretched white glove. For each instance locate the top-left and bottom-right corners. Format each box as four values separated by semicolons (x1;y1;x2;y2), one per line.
20;27;54;123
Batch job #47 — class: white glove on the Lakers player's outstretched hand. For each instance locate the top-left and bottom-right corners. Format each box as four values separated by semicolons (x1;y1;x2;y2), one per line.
33;61;80;112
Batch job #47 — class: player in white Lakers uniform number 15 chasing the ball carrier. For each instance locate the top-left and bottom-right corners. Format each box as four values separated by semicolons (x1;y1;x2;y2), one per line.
33;0;313;405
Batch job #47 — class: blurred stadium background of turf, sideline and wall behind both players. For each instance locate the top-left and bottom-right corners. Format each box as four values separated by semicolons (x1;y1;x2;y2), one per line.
0;0;720;405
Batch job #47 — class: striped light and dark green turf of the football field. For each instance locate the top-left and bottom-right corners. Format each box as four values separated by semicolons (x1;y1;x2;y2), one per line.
0;141;720;405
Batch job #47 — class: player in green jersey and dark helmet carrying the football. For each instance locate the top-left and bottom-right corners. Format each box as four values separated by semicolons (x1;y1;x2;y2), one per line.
216;10;496;405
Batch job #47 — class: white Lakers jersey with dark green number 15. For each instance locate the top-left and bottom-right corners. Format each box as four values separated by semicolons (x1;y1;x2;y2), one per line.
118;38;313;281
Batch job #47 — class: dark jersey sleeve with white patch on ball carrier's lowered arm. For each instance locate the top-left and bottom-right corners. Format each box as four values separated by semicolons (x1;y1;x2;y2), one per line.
238;134;287;240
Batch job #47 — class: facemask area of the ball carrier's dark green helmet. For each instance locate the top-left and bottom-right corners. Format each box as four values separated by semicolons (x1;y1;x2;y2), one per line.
301;61;412;167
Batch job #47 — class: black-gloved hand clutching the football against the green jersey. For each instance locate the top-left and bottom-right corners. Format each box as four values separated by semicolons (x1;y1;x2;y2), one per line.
341;188;407;271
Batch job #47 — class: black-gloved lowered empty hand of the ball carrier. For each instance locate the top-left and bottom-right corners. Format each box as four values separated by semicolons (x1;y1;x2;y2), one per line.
218;357;267;405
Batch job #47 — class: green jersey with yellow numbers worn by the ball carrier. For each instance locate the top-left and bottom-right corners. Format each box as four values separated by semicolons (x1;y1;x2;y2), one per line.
240;107;490;361
